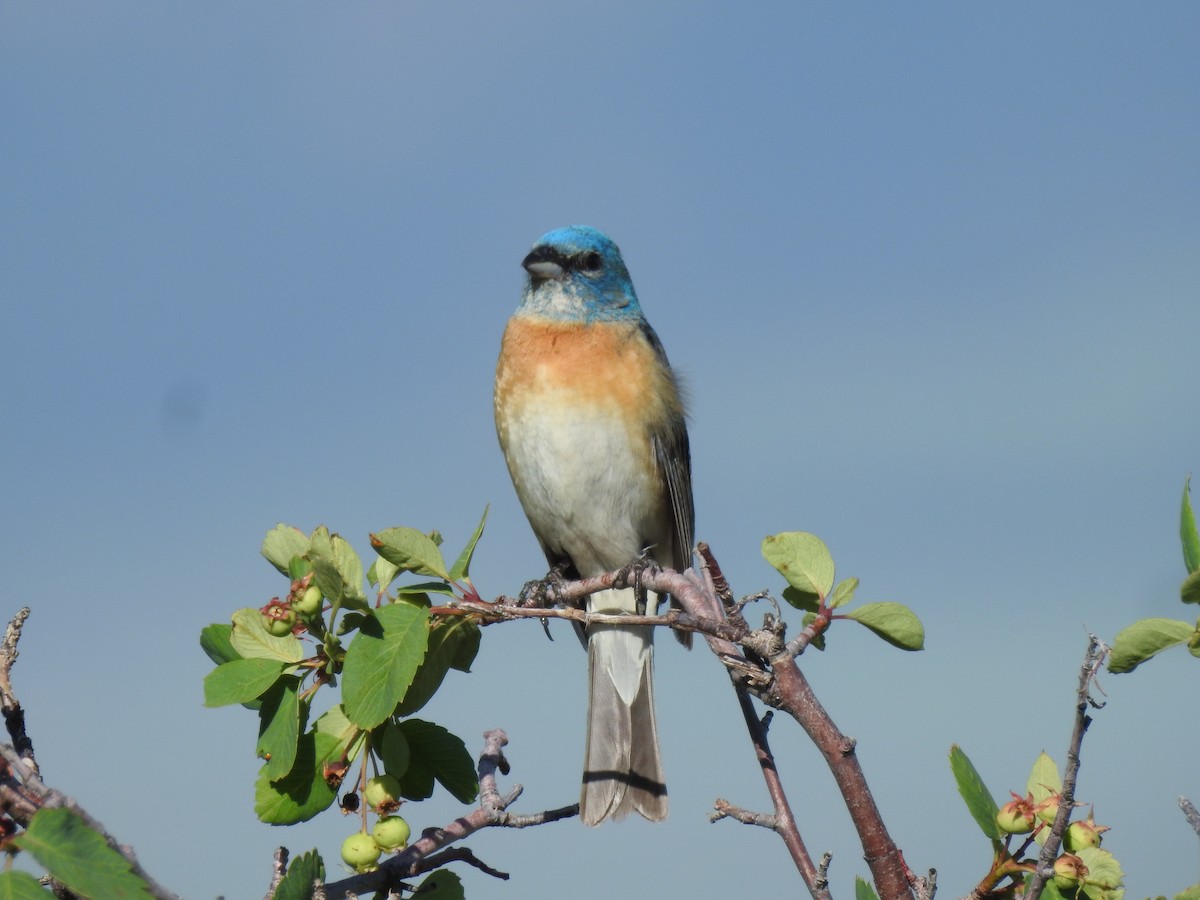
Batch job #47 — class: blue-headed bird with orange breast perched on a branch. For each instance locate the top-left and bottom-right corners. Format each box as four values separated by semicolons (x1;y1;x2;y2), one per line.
494;226;695;826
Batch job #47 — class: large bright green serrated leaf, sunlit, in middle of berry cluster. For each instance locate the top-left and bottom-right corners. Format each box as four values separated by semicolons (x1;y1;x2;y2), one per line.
342;602;430;731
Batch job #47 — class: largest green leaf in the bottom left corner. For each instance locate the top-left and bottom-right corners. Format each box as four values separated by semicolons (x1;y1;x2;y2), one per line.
12;809;151;900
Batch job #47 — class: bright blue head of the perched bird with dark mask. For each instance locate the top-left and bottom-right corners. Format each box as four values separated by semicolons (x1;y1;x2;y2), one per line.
521;226;642;322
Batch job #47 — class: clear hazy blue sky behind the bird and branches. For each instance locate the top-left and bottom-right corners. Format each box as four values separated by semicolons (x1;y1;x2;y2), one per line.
0;1;1200;900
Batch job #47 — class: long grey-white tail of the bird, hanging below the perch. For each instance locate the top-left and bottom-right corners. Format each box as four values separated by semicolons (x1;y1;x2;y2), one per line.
580;588;667;826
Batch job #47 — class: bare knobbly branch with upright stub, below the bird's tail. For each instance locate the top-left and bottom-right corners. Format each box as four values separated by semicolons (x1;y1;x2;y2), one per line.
316;728;580;896
